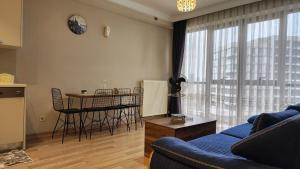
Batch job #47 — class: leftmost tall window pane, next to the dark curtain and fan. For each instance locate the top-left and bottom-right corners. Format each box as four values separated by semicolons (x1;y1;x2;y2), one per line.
181;30;207;116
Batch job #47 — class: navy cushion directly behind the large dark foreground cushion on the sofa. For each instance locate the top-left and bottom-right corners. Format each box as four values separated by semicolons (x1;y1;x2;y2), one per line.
250;109;299;134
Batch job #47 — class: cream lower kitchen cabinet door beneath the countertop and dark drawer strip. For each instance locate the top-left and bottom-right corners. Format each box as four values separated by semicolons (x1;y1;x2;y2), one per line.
0;97;25;146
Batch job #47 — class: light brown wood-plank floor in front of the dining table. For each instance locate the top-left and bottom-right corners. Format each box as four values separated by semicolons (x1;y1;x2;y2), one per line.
9;127;148;169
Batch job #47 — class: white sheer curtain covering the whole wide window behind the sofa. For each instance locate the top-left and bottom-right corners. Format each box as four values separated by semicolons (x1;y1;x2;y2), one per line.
182;0;300;130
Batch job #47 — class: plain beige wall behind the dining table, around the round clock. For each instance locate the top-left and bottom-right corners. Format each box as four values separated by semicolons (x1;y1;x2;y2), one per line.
16;0;171;134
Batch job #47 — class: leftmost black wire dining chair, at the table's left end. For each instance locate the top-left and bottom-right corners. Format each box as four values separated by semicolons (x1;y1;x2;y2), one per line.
51;88;82;144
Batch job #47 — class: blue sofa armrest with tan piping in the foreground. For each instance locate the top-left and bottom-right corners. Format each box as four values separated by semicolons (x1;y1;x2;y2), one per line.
151;137;276;169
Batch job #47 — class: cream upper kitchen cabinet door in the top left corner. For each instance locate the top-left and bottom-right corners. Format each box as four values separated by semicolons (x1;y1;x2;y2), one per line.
0;0;22;47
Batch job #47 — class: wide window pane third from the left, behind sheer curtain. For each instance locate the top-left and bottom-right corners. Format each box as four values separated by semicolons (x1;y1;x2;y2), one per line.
241;19;280;122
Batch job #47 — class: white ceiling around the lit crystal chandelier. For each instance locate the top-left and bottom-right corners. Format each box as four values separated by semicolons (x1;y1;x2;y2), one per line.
75;0;261;27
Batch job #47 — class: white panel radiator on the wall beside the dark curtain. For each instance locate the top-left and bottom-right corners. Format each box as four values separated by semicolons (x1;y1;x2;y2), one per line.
142;80;168;117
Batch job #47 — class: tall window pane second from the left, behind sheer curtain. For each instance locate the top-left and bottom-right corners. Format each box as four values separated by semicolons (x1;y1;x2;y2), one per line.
210;26;239;130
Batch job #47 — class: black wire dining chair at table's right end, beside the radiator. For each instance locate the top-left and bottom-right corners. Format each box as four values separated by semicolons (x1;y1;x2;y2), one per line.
130;87;144;129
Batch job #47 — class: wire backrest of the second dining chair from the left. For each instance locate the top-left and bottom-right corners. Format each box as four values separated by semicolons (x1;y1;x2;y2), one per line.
92;89;113;108
